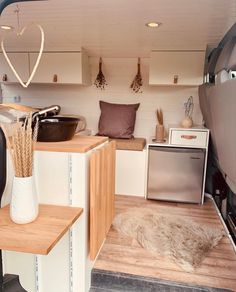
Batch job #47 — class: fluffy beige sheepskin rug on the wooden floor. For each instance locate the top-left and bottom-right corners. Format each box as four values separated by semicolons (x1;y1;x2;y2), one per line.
113;208;224;272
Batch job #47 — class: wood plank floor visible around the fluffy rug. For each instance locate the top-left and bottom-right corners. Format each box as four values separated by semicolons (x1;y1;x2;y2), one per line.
95;196;236;291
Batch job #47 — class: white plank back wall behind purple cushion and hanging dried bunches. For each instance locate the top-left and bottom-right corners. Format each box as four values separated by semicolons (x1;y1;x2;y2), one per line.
2;58;202;138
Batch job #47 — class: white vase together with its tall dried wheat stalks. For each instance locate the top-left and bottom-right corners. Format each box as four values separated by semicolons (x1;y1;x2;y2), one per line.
1;114;38;224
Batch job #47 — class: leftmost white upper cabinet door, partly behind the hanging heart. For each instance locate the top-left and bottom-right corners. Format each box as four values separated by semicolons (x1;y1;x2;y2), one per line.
0;53;29;82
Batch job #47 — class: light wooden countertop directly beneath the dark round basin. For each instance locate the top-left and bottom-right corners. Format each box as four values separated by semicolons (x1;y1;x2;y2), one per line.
35;135;108;153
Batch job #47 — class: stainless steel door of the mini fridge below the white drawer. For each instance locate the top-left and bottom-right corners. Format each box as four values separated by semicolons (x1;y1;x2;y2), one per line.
147;146;205;203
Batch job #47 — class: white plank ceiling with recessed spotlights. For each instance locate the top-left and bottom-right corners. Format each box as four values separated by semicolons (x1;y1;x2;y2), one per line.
0;0;236;57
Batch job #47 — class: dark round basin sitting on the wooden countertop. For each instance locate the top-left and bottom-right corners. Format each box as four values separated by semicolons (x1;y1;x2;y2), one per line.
37;116;79;142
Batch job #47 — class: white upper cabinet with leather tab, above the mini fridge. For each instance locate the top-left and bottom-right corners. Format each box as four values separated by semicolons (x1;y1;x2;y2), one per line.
149;51;205;86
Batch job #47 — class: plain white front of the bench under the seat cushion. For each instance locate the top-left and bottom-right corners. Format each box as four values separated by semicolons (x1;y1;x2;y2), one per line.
115;150;146;197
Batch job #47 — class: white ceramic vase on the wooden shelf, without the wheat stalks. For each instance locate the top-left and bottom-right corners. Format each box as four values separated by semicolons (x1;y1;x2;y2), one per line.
10;176;38;224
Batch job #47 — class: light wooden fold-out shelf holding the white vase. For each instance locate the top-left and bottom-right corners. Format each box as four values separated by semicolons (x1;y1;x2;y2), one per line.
0;205;83;255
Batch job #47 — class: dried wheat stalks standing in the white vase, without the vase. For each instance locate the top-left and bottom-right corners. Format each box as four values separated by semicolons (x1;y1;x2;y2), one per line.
1;113;38;177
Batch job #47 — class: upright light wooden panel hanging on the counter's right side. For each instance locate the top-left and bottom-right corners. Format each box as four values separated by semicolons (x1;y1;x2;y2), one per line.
90;141;116;260
